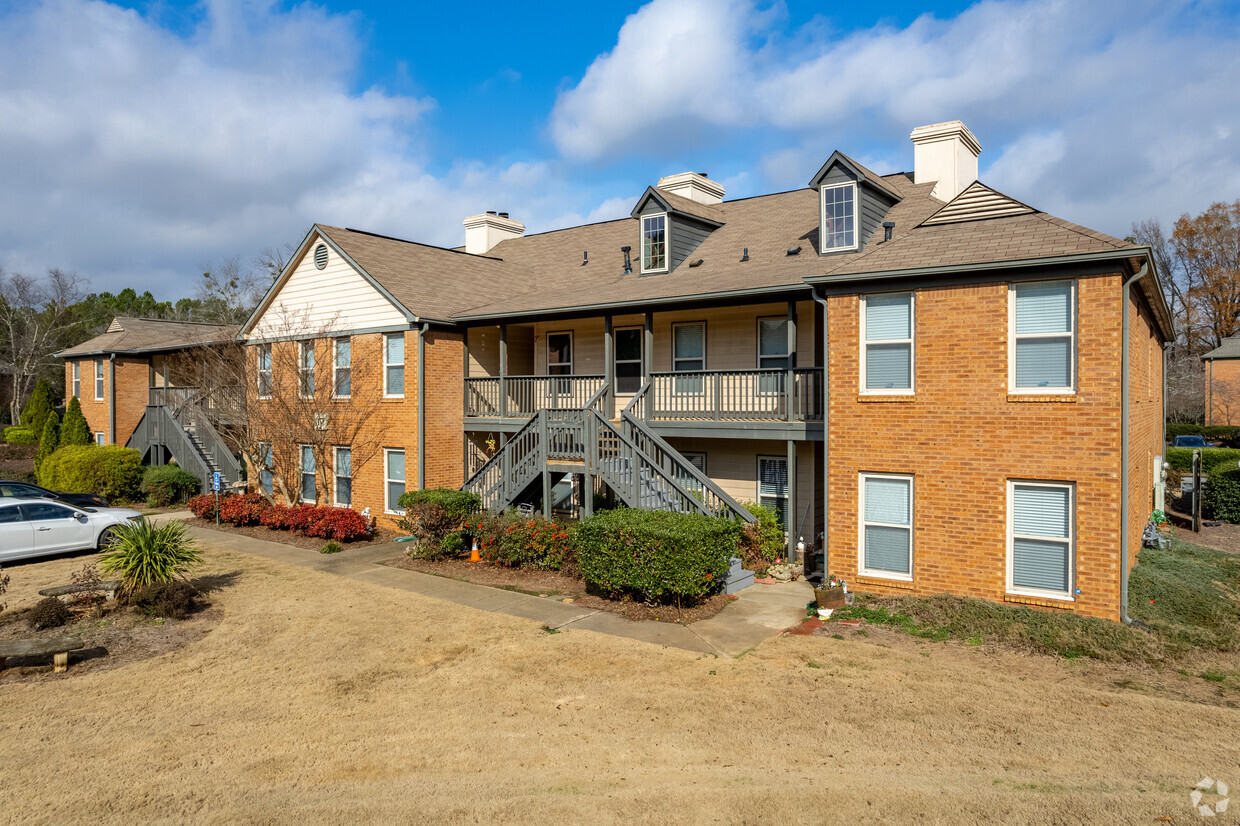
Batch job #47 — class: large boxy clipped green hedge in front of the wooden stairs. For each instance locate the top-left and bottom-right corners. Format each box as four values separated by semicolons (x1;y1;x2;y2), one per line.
577;510;740;602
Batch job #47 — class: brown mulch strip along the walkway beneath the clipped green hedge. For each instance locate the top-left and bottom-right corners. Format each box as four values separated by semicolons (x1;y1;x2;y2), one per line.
387;556;733;624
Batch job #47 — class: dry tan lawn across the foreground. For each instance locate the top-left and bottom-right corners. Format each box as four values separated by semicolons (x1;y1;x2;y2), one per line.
0;540;1240;825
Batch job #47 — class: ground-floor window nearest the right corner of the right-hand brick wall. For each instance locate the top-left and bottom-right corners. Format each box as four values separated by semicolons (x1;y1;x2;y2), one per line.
1007;480;1076;599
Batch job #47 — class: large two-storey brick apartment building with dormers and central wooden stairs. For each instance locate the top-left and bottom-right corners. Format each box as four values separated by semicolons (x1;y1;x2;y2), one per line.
225;122;1173;619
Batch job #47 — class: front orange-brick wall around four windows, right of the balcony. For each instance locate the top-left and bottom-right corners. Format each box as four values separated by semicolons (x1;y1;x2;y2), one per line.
828;275;1135;619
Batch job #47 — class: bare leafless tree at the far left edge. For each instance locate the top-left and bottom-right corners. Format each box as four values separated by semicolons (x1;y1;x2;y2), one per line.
0;268;83;422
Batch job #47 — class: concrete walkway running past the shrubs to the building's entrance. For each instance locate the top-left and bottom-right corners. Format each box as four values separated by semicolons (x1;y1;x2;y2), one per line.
164;511;813;657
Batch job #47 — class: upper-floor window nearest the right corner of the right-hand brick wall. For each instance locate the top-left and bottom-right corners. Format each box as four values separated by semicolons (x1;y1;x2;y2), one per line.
1008;282;1076;393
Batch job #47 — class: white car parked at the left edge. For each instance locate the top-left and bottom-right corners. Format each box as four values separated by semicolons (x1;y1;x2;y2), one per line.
0;496;143;562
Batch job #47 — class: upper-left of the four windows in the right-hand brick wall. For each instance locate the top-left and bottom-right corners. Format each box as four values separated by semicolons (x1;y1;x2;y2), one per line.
861;293;915;394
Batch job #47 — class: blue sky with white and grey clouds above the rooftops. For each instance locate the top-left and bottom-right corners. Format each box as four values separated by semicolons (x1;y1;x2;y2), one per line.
0;0;1240;298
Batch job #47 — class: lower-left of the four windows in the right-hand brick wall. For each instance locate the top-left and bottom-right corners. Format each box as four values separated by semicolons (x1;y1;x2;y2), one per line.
857;474;913;580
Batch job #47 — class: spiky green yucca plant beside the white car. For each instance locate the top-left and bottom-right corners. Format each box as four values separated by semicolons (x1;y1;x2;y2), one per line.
99;520;202;594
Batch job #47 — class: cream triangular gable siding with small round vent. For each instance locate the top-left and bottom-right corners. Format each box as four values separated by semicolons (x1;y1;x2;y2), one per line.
249;229;408;340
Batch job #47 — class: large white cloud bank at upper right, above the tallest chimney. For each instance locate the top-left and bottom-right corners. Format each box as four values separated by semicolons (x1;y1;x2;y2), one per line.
551;0;1240;232
